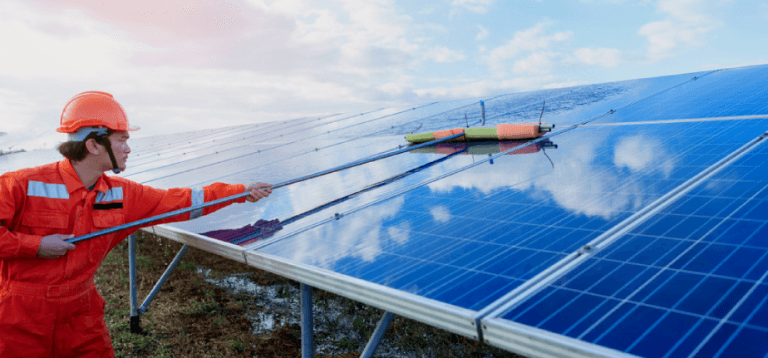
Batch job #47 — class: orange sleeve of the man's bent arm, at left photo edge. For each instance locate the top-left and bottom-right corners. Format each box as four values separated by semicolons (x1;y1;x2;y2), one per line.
0;174;43;260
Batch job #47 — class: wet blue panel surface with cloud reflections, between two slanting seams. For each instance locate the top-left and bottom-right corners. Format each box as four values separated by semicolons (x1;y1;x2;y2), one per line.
250;121;768;310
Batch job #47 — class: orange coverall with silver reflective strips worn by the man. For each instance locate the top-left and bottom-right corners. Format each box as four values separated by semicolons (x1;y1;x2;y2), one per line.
0;159;245;357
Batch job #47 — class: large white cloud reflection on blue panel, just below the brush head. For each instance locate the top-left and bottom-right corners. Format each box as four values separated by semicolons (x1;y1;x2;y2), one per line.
429;130;675;220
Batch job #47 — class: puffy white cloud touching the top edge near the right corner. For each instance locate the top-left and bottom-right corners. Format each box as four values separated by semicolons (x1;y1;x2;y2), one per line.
638;0;721;62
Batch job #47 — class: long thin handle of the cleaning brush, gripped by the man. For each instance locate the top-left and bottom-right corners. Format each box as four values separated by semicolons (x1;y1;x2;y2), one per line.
65;133;464;244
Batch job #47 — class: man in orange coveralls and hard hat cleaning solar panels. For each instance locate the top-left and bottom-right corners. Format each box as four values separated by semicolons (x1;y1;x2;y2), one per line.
0;92;271;358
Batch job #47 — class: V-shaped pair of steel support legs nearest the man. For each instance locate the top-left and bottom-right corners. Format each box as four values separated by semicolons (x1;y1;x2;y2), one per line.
128;233;189;334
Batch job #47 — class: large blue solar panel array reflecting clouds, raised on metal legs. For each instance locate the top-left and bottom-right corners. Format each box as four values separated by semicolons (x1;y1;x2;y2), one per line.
0;66;768;357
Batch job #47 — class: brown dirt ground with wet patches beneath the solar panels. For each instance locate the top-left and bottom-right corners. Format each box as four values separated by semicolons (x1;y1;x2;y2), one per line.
96;232;518;358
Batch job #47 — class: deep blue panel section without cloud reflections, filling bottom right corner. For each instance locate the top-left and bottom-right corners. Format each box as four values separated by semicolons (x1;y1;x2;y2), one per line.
503;122;768;357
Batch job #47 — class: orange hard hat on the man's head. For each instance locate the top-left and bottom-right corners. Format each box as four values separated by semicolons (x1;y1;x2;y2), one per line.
56;91;139;133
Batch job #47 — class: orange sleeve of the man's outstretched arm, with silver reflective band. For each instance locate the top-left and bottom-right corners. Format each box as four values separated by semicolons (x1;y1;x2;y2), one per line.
125;183;245;226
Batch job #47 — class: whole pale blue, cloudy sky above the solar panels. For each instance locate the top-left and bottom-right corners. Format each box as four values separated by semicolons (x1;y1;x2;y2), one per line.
0;0;768;151
